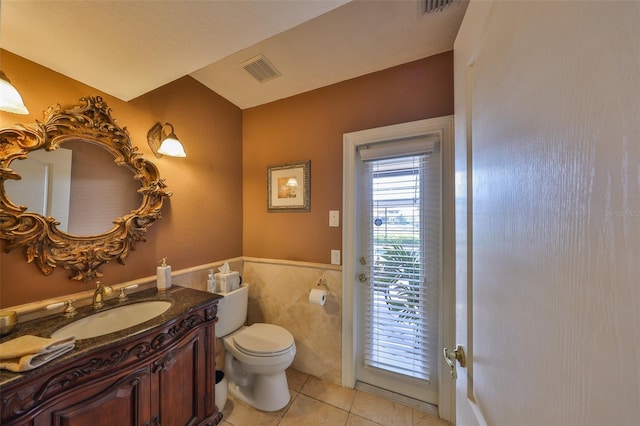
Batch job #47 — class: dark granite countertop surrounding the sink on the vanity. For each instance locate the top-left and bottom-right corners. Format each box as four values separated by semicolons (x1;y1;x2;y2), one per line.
0;285;221;390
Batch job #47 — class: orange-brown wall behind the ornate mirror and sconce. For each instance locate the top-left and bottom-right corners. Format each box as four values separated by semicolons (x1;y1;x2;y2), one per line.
0;50;242;307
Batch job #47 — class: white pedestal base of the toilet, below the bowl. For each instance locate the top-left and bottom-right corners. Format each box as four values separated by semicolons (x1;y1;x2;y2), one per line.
229;371;291;411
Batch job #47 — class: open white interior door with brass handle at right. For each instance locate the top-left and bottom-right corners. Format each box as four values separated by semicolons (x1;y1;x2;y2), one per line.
446;1;640;426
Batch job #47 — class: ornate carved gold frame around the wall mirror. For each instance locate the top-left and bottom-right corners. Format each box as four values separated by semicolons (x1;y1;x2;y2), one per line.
0;96;171;282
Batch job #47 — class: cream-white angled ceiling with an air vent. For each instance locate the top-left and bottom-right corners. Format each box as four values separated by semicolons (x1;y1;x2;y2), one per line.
0;0;467;109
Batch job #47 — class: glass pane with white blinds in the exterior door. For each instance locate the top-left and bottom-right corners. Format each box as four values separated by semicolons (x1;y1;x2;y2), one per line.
365;155;440;380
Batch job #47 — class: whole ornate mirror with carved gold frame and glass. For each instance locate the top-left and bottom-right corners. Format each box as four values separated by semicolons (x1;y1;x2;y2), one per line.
0;96;171;281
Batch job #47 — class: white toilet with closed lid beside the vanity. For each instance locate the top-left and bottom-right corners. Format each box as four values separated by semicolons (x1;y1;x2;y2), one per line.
216;283;296;411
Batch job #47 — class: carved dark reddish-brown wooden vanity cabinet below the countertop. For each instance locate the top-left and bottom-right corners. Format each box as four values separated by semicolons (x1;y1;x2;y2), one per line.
0;292;222;426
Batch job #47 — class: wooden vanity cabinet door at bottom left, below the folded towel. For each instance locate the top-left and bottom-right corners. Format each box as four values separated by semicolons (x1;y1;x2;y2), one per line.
34;367;151;426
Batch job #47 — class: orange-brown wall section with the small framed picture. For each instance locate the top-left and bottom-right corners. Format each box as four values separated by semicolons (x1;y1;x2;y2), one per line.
242;52;453;263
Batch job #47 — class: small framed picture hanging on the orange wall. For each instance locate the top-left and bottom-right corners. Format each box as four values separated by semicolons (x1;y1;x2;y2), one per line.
267;160;311;213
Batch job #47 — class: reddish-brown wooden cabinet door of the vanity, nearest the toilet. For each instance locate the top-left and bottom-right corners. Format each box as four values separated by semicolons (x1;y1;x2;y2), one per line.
151;329;209;425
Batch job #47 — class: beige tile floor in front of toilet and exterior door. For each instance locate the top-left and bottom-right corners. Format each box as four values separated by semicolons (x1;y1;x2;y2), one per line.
221;369;450;426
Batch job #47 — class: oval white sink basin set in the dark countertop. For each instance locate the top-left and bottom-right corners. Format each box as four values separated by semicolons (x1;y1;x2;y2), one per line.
51;300;171;340
